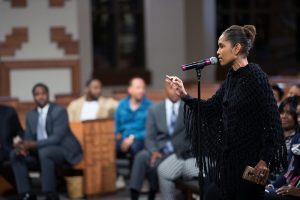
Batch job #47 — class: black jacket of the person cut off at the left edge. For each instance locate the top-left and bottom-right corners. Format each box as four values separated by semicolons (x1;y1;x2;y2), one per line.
0;105;23;162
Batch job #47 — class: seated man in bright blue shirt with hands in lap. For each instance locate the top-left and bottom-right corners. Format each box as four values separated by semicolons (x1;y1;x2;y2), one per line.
115;78;151;157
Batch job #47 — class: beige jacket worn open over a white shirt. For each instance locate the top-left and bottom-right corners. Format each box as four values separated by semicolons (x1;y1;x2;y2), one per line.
68;96;119;122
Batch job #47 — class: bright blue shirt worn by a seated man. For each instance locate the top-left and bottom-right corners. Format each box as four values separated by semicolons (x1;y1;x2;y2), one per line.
115;96;152;140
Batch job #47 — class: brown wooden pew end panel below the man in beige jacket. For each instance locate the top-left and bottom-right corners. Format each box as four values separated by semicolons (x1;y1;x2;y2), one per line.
70;119;116;196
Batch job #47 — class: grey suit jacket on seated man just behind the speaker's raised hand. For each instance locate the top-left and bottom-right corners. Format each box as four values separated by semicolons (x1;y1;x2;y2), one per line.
145;100;191;158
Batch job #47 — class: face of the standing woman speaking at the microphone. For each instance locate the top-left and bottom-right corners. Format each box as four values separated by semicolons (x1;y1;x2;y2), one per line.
217;34;236;66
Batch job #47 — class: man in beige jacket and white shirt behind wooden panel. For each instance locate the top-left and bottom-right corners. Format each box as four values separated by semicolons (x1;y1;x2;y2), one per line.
68;79;118;122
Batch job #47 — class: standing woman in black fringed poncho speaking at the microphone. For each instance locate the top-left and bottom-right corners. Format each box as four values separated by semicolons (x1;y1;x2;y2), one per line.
166;25;286;200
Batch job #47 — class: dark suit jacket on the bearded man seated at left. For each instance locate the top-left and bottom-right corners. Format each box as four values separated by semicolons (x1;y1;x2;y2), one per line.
24;103;83;164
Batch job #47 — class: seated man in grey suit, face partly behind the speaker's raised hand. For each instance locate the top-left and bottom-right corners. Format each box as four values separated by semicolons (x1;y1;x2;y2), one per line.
130;84;198;200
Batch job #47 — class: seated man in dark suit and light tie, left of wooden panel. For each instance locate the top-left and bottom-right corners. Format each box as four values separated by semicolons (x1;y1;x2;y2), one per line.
10;83;83;199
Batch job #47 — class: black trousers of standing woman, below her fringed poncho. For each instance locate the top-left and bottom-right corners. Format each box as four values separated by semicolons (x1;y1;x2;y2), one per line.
204;179;264;200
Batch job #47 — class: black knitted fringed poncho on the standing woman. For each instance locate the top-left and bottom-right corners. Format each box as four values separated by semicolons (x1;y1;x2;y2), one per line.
183;63;286;189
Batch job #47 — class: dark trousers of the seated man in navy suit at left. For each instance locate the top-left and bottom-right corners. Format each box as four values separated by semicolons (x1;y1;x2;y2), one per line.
10;146;67;193
